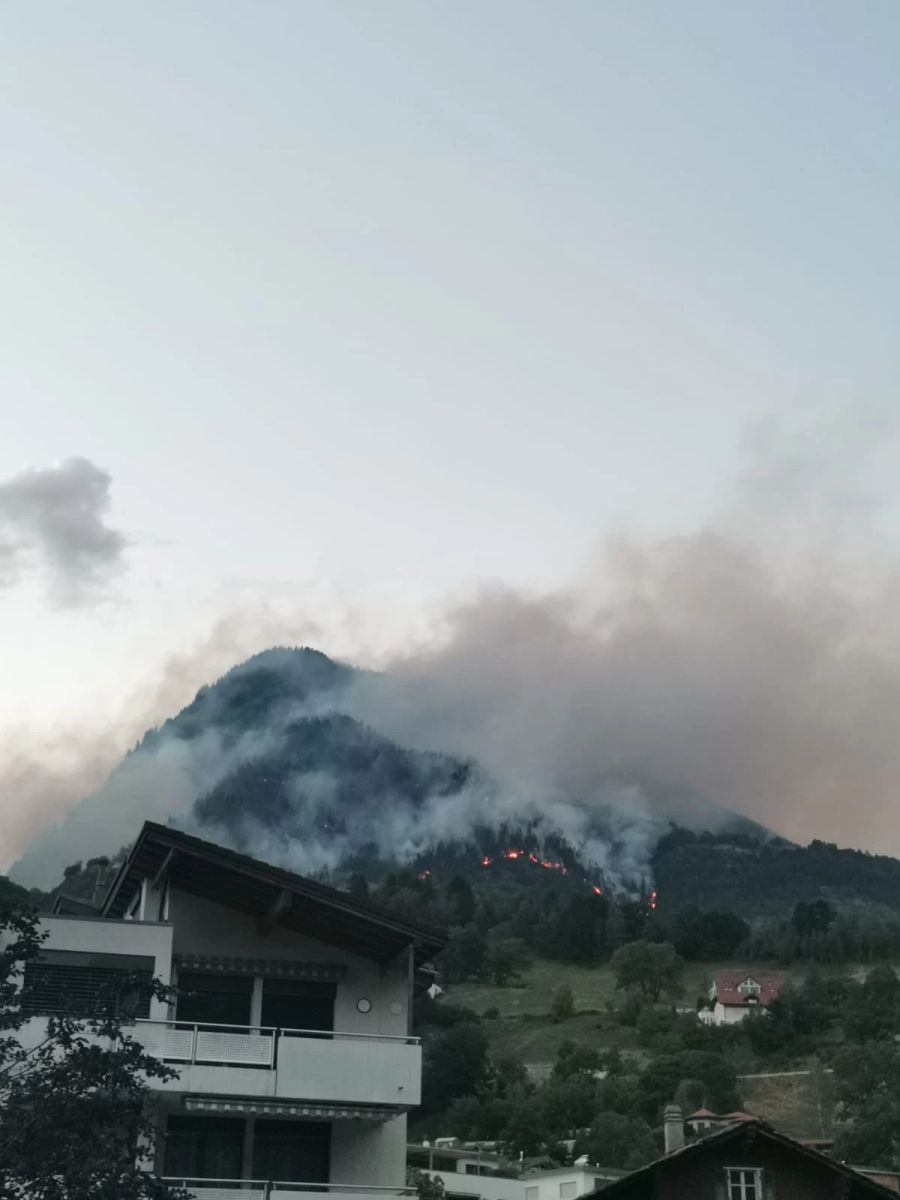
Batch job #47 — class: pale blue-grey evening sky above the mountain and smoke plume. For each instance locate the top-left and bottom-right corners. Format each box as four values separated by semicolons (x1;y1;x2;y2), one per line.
0;0;900;863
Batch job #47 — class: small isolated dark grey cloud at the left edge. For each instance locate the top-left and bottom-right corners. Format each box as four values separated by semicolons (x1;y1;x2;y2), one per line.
0;457;127;605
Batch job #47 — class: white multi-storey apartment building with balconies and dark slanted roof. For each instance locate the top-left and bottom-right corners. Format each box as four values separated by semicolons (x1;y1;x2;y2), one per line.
15;822;442;1200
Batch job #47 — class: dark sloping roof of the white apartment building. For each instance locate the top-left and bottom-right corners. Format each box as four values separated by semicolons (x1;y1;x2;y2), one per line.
102;821;446;965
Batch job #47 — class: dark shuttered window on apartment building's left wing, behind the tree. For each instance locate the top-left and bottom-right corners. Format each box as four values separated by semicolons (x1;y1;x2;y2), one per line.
22;950;155;1016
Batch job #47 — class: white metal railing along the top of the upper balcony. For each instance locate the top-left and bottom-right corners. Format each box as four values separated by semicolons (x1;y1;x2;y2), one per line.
132;1020;420;1068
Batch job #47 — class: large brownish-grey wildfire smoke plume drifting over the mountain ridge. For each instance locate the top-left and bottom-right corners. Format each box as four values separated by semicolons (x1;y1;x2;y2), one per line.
10;417;900;882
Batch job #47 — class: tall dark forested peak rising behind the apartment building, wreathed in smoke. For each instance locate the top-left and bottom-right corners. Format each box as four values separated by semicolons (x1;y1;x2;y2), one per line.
11;648;475;886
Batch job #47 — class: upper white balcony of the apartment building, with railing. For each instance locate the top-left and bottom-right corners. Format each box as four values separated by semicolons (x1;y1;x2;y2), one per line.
132;1021;421;1104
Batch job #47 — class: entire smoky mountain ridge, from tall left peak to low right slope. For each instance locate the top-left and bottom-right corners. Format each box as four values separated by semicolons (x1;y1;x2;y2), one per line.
12;647;900;912
